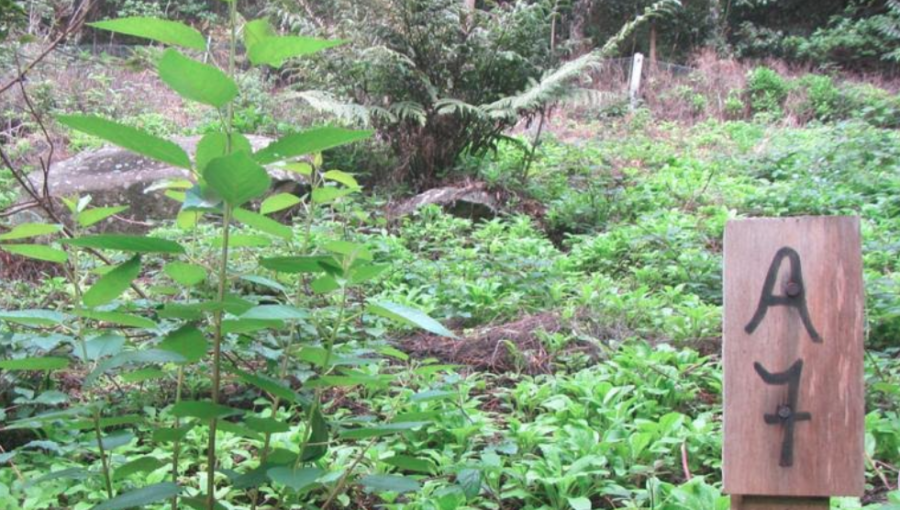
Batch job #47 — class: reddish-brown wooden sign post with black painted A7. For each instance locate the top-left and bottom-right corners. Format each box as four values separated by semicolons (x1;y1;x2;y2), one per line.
722;217;865;510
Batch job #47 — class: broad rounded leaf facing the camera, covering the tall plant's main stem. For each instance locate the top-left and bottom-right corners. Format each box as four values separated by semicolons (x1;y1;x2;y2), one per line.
203;152;271;207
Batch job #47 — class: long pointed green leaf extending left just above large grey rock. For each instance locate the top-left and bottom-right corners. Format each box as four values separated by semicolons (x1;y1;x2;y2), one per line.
56;115;191;169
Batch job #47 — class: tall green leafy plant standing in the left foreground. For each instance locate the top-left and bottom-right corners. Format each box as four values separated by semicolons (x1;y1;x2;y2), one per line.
0;0;452;510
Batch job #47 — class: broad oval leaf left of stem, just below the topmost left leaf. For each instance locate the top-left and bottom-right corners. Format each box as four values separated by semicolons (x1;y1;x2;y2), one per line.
157;49;238;108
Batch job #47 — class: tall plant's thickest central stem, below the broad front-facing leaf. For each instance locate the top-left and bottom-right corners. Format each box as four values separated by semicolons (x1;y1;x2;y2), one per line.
206;205;232;510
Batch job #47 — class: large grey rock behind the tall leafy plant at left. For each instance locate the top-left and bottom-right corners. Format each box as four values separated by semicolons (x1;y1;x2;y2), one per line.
23;136;298;232
